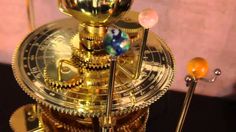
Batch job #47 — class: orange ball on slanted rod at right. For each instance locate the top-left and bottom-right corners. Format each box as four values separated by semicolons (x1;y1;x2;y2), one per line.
187;57;208;79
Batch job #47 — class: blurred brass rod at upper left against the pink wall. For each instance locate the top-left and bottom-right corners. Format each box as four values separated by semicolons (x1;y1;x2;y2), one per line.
26;0;36;31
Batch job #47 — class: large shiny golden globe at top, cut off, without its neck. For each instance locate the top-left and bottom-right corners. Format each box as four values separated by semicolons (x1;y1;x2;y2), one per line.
58;0;133;27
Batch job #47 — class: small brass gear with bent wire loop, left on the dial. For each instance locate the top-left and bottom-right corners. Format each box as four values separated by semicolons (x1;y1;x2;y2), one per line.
43;63;83;90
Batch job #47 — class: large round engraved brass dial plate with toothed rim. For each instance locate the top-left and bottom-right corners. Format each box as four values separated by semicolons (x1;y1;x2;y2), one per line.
13;16;174;116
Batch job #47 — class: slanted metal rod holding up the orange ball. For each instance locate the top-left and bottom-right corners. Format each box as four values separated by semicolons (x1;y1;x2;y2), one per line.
176;79;197;132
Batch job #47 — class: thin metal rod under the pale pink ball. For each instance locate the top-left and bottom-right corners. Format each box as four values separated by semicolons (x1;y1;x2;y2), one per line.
135;29;149;79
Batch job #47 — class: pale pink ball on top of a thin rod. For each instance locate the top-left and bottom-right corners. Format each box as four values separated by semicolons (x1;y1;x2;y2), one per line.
138;9;159;29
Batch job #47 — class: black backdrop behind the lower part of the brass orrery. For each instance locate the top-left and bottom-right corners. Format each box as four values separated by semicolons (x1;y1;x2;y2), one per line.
0;64;236;132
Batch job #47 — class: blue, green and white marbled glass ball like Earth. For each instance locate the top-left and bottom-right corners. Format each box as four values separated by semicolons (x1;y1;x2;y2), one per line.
103;28;130;56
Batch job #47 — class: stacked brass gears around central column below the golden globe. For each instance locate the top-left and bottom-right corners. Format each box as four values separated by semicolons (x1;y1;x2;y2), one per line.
71;33;110;70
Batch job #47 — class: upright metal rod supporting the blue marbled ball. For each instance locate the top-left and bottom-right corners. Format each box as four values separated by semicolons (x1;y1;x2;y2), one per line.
102;56;117;132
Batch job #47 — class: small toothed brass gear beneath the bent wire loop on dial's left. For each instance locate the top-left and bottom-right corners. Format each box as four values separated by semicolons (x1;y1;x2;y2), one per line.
43;65;83;89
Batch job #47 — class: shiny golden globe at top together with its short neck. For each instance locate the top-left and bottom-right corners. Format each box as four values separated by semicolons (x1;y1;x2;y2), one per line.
58;0;133;49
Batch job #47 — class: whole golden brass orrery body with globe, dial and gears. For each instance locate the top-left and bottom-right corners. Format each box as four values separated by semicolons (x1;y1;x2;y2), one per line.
10;0;175;131
